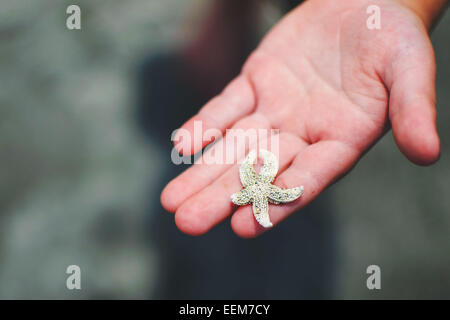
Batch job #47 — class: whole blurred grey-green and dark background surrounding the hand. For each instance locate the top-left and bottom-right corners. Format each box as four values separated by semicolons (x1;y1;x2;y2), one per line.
0;0;450;299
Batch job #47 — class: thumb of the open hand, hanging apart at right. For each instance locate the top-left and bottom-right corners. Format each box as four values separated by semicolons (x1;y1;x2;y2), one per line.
385;38;440;165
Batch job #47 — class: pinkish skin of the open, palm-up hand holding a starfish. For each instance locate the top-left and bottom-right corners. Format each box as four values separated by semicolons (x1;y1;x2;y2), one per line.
161;0;445;238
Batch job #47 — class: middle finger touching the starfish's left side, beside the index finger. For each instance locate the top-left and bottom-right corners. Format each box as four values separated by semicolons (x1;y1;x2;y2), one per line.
175;133;307;235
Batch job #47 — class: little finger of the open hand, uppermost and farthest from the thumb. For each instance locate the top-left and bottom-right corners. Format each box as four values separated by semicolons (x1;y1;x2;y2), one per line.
174;75;255;155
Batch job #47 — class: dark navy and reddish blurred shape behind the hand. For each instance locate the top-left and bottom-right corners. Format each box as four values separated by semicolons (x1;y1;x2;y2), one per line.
138;0;336;299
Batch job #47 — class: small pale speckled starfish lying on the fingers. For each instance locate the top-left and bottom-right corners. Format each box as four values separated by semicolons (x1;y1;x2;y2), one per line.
231;149;304;228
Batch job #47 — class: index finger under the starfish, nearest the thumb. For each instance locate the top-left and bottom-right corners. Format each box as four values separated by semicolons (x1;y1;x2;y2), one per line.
231;140;360;238
